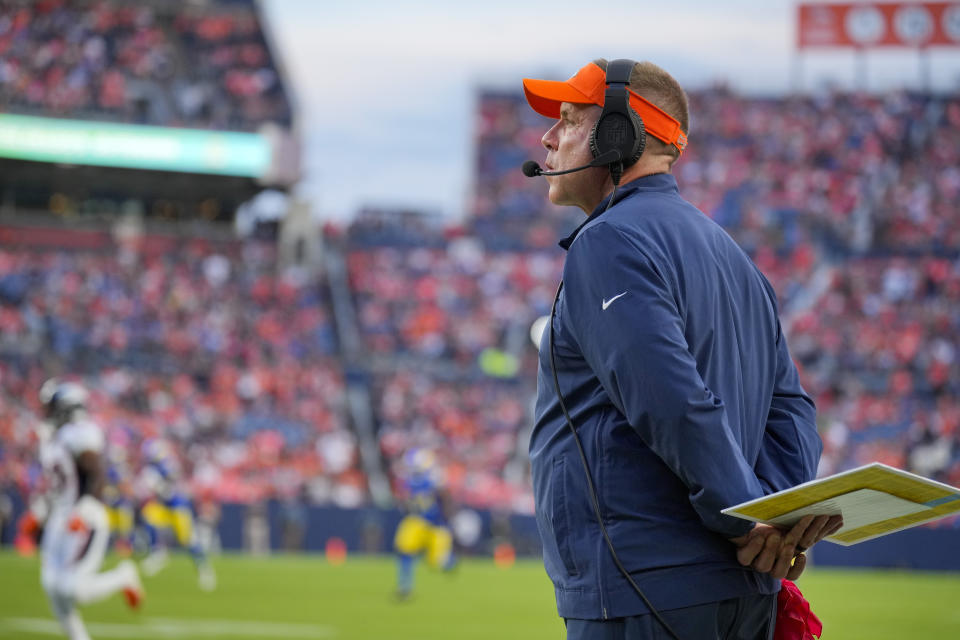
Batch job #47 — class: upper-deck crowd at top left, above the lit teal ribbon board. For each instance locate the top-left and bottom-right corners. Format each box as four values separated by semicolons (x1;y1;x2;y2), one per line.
0;0;291;130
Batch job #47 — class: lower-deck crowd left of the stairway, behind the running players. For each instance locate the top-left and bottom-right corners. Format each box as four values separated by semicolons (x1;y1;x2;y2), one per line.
0;238;366;506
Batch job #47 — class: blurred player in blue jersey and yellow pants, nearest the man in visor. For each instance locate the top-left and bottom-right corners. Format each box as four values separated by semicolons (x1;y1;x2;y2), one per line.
393;449;455;599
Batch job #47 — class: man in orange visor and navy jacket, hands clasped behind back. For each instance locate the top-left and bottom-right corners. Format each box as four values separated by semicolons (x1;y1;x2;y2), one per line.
524;60;841;640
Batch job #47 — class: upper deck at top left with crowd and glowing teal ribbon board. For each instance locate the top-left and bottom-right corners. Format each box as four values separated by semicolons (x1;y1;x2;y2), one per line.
0;0;300;221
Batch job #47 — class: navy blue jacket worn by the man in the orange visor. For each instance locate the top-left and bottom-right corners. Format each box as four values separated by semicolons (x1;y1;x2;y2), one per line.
530;174;822;619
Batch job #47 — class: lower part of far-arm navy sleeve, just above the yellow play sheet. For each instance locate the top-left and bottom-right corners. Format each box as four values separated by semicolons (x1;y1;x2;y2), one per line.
754;322;823;493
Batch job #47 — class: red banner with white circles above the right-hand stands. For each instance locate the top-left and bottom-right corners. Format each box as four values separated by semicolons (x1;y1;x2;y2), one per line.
797;1;960;49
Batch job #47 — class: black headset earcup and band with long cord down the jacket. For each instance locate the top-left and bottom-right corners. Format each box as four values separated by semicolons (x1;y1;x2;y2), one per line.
547;59;680;640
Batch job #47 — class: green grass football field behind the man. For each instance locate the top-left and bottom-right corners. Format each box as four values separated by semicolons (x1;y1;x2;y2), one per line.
0;551;960;640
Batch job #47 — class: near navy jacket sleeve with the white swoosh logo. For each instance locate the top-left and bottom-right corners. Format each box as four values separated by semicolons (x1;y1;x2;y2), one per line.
564;222;764;538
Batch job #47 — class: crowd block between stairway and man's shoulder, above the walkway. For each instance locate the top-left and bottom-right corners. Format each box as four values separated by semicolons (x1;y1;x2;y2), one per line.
348;238;561;364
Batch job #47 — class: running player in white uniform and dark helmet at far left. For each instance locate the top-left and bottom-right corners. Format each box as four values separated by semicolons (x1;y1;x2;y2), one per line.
40;381;143;640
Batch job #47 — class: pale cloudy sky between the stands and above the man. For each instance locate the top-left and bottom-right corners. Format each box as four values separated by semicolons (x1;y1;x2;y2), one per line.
261;0;960;221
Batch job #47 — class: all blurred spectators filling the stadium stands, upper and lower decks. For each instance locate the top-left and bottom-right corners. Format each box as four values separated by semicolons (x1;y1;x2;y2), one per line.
0;56;960;524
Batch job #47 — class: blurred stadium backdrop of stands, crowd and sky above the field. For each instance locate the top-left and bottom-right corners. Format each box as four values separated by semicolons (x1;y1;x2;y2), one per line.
0;0;960;637
